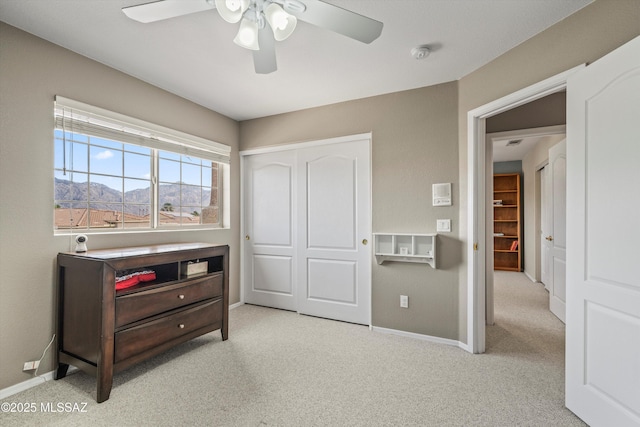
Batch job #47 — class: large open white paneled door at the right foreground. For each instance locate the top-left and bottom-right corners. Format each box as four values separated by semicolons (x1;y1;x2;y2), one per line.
566;37;640;426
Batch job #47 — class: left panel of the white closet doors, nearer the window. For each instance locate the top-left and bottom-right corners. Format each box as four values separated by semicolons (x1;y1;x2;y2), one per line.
243;151;297;310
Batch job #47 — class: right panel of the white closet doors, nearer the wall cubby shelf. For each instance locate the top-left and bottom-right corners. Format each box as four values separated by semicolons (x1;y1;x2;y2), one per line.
298;140;371;325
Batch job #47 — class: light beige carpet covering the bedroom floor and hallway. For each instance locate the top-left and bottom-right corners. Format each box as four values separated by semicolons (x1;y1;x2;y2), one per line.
0;272;584;426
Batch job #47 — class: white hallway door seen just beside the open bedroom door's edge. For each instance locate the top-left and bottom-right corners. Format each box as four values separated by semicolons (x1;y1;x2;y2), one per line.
545;140;567;322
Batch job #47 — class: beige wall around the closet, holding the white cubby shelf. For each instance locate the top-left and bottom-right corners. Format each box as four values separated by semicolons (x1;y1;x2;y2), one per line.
240;82;462;340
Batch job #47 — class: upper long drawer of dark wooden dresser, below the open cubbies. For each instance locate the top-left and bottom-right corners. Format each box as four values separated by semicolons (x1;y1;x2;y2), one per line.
115;273;223;329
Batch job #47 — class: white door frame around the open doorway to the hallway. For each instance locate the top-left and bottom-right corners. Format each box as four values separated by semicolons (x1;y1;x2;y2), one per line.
466;64;586;353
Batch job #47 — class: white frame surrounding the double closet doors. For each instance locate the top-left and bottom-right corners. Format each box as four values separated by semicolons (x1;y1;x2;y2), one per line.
238;132;373;326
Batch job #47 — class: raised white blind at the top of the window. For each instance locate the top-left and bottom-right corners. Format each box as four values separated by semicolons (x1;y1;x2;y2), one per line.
54;95;231;164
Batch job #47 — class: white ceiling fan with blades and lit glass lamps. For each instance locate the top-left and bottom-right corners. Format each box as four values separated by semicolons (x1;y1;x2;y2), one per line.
122;0;383;74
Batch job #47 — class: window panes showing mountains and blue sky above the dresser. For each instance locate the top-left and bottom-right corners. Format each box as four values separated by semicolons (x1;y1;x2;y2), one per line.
54;129;220;230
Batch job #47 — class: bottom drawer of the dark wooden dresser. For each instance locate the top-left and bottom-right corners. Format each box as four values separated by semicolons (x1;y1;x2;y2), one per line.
114;299;223;363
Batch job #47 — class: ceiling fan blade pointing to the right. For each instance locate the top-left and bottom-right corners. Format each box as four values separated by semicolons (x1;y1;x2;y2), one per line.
284;0;384;43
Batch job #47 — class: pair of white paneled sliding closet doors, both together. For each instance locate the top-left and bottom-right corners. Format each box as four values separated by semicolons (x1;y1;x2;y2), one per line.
243;136;371;324
